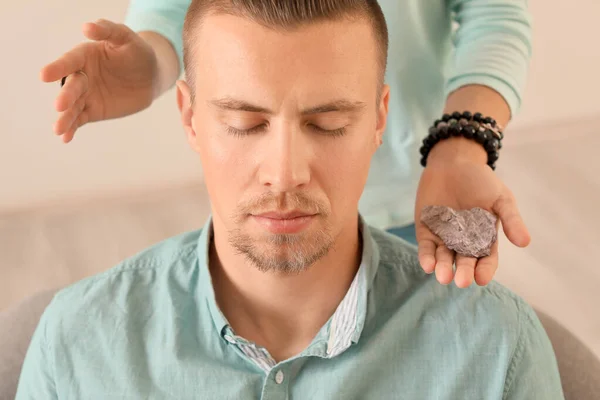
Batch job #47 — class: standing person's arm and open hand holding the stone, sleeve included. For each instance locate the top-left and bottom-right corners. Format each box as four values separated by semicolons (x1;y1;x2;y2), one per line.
415;0;531;287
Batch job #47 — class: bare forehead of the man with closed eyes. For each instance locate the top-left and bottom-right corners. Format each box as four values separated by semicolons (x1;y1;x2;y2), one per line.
193;15;379;94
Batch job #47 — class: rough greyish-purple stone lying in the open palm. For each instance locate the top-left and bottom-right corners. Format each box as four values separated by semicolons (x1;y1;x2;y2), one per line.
421;206;498;258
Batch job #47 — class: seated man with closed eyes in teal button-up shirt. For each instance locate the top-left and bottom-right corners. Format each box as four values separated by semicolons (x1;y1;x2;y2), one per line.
17;0;562;400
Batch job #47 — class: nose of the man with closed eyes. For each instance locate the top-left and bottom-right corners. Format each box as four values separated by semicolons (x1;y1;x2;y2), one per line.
259;124;312;192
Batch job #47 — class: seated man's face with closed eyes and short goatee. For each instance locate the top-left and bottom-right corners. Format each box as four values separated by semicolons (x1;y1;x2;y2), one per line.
178;15;388;272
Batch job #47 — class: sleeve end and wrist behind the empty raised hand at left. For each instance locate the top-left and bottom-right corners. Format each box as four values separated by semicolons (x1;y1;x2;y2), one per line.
125;0;191;98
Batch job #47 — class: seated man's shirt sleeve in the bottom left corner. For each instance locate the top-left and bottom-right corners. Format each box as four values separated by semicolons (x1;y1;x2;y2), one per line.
15;307;58;400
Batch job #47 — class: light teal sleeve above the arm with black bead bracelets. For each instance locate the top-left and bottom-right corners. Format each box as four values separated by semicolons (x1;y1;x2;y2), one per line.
446;0;532;117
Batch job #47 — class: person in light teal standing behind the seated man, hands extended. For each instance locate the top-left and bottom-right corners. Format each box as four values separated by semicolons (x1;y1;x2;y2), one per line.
41;0;531;288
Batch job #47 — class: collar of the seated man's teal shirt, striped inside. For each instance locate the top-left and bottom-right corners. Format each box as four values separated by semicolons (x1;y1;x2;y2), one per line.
197;215;379;358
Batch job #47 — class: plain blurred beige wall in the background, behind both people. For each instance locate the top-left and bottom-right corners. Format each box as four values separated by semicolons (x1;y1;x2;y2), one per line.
0;0;600;212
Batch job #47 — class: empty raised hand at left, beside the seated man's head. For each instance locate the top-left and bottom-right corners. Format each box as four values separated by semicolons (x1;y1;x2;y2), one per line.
40;20;158;143
